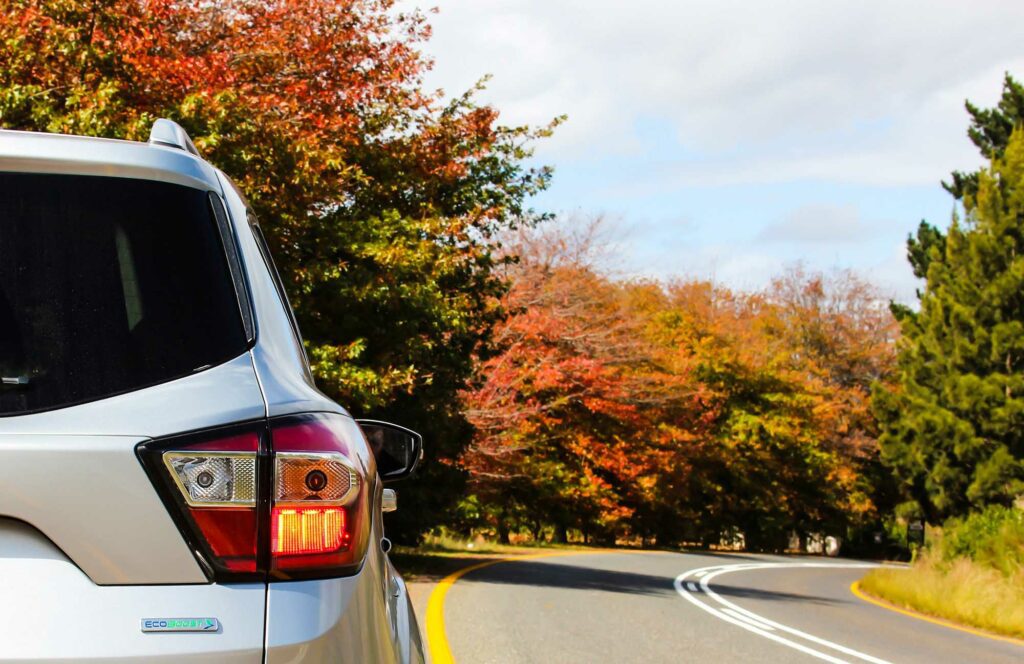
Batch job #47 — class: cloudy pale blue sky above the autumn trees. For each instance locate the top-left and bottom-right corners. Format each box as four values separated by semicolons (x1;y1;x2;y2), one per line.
406;0;1024;302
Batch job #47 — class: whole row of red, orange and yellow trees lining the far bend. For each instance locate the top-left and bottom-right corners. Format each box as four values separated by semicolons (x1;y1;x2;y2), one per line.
462;223;894;537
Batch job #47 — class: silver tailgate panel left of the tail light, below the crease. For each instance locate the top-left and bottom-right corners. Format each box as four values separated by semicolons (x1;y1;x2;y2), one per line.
0;433;207;584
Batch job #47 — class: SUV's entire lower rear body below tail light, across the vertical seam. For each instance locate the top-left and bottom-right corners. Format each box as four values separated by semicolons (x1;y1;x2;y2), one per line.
0;518;423;664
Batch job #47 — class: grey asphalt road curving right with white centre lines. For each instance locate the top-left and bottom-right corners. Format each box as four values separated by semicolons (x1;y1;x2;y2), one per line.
407;552;1024;664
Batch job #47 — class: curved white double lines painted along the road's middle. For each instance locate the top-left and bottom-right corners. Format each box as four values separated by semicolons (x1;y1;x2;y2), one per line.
675;563;889;664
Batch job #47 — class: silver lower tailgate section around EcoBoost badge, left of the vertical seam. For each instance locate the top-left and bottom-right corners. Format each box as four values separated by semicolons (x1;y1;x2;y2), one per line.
0;518;266;664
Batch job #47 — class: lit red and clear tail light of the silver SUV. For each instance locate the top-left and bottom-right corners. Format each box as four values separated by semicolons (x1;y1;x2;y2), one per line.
138;414;374;581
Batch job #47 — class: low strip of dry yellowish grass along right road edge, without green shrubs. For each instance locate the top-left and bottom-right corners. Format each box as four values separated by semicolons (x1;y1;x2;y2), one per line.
860;552;1024;637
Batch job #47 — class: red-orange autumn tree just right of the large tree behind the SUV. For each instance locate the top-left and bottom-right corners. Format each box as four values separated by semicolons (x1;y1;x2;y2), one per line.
460;225;686;539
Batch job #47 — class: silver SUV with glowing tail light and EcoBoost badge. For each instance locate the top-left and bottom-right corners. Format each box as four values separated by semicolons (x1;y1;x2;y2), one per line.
0;120;423;663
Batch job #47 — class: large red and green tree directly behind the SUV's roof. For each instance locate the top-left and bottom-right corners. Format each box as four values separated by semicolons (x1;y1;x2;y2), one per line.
0;0;551;532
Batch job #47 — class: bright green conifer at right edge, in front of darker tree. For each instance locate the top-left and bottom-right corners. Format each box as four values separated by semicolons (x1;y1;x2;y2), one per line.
874;129;1024;523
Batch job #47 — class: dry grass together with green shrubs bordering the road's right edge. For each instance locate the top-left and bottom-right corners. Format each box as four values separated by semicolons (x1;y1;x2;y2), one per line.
860;509;1024;638
